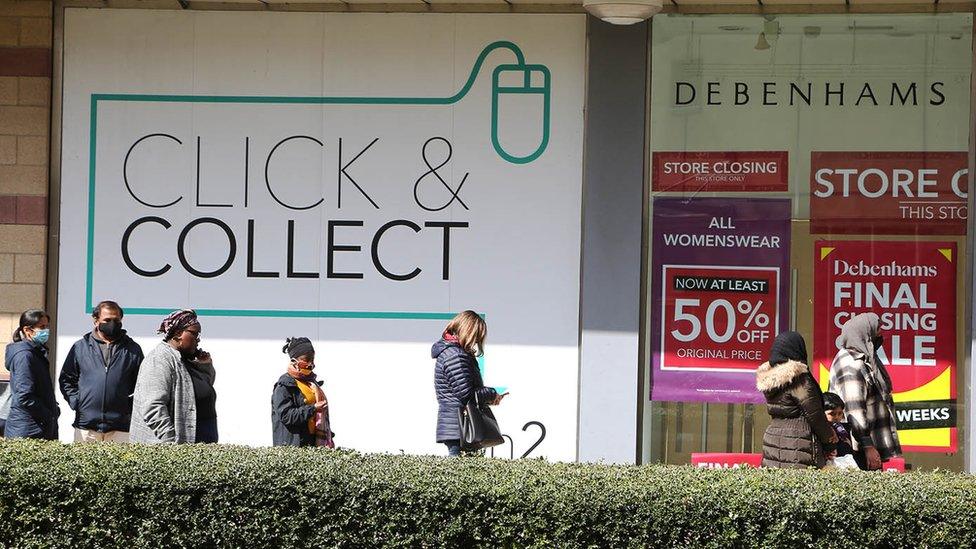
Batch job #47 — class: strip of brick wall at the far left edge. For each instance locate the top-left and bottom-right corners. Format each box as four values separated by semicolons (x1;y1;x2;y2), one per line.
0;0;53;379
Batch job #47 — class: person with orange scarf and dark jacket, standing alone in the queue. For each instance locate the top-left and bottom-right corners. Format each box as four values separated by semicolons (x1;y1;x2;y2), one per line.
271;337;335;448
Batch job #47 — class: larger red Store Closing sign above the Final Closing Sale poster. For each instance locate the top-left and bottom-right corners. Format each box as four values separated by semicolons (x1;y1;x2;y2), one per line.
810;152;969;235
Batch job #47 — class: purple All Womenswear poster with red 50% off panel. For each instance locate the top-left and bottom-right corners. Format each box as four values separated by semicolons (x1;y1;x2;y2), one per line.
651;198;790;403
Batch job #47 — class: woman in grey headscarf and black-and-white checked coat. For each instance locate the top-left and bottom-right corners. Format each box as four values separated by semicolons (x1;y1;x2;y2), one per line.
830;313;901;470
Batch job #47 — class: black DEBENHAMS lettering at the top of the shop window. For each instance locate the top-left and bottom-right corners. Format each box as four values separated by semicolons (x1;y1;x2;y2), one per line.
674;81;946;107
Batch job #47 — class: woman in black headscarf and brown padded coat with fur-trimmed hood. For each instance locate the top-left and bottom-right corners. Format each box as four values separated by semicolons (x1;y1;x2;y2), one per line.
756;332;837;469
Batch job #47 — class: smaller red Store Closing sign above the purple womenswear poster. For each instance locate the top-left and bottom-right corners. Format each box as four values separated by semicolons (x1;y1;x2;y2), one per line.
651;151;790;193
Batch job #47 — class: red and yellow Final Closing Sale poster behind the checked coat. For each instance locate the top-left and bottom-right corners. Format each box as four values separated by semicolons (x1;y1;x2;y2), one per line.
814;241;957;452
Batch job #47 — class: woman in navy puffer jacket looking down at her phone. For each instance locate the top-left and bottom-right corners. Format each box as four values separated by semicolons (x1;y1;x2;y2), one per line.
430;311;505;456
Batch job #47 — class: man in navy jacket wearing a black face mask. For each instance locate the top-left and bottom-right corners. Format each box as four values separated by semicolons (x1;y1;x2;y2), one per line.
58;301;143;442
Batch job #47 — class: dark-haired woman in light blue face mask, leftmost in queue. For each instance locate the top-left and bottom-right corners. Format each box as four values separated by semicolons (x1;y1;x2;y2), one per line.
4;309;61;440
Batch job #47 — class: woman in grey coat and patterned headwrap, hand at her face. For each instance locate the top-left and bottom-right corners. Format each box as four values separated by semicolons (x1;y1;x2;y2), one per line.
129;309;217;444
